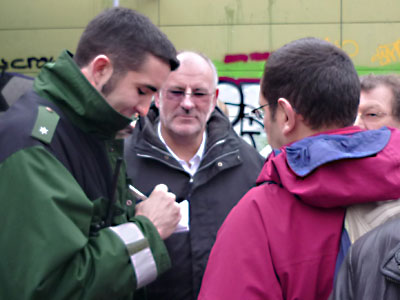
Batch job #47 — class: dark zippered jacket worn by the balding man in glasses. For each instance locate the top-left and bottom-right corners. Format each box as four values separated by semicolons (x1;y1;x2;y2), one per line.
125;105;264;300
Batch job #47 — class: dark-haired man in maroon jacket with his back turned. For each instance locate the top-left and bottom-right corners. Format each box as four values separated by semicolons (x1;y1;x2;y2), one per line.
199;38;400;300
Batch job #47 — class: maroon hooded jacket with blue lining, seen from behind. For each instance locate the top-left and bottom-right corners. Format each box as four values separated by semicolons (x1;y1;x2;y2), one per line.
199;127;400;300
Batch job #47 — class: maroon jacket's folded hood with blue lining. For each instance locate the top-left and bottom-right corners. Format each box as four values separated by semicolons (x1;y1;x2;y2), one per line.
257;127;400;207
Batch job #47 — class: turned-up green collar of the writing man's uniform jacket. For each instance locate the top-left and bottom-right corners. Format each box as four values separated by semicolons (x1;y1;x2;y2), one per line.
34;50;132;139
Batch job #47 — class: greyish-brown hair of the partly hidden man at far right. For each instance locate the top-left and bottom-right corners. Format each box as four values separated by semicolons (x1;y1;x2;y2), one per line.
360;74;400;121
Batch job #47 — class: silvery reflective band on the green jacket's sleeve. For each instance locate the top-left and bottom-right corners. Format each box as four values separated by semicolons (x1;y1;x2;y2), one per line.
109;223;157;289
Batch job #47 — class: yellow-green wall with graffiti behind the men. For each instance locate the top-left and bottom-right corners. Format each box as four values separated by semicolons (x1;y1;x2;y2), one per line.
0;0;400;149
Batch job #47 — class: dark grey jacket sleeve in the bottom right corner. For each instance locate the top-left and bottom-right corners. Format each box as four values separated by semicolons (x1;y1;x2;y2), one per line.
329;219;400;300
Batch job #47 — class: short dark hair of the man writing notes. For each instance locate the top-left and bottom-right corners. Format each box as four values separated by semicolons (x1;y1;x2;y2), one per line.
74;7;179;73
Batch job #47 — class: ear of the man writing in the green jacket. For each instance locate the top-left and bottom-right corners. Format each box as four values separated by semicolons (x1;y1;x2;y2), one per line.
81;54;114;91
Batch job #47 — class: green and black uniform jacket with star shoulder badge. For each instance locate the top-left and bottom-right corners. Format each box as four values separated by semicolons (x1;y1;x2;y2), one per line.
0;51;170;299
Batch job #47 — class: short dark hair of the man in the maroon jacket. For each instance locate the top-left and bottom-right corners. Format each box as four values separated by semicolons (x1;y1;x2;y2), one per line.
261;38;360;130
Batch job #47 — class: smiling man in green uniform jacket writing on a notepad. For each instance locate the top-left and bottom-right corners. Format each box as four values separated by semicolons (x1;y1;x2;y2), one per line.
0;8;180;299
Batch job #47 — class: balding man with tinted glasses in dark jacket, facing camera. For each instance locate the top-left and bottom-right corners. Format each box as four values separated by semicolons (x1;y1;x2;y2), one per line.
125;51;263;300
